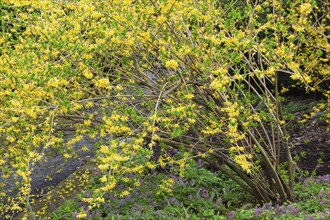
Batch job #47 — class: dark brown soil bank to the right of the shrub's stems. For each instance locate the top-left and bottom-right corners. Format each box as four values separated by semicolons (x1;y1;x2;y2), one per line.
284;96;330;175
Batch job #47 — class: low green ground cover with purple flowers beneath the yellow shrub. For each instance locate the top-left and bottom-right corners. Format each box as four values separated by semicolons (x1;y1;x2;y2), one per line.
50;159;330;220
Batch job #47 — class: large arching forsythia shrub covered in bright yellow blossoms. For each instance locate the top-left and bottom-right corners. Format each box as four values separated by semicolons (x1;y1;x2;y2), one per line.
0;0;330;218
